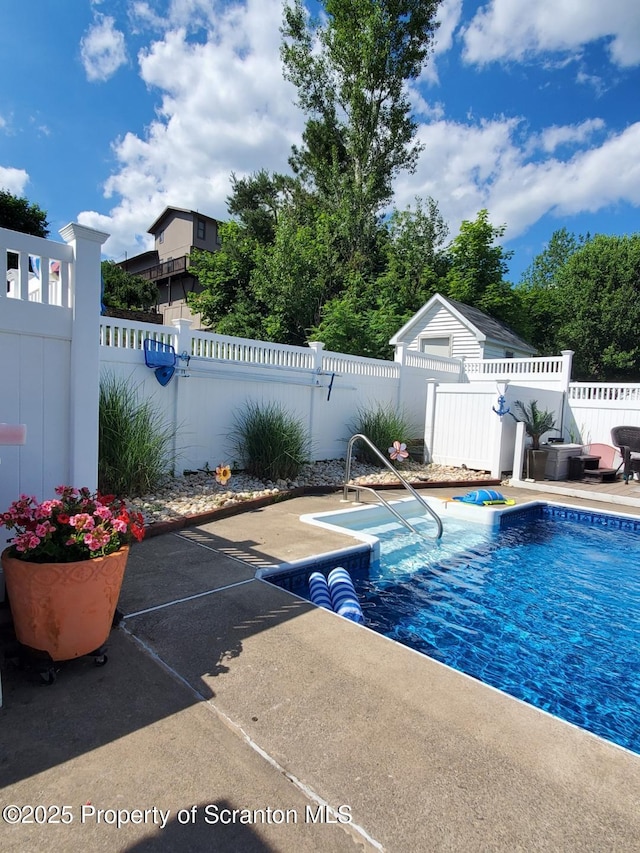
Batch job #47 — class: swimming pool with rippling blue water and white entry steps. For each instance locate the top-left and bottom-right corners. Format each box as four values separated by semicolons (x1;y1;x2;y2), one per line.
276;502;640;753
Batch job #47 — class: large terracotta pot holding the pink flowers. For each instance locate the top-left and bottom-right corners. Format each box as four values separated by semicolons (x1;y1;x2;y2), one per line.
2;545;129;661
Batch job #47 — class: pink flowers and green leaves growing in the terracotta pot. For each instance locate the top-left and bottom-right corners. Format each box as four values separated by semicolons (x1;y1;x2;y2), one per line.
0;486;144;563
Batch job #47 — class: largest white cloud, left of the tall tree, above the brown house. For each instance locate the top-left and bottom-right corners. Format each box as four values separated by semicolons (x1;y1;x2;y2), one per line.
79;0;303;257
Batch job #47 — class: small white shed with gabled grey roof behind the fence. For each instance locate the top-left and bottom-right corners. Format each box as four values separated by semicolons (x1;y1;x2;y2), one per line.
389;293;537;359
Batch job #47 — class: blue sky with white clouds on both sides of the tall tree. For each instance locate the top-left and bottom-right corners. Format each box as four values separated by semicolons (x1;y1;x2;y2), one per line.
0;0;640;283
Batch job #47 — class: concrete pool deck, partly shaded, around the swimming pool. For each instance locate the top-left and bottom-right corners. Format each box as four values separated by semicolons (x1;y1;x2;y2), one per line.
0;484;640;853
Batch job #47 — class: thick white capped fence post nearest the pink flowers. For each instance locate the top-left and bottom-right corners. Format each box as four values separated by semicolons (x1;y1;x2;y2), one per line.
60;222;109;491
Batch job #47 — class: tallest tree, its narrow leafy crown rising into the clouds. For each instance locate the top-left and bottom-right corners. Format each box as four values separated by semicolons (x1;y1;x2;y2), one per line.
281;0;440;269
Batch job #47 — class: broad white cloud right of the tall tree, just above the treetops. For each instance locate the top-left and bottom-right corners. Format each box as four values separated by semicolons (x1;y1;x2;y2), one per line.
396;119;640;239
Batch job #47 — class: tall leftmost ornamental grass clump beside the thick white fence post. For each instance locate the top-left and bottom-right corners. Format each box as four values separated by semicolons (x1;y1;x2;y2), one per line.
98;375;175;497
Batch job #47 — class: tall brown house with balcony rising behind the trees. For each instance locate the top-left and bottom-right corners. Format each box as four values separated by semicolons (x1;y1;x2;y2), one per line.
118;207;220;329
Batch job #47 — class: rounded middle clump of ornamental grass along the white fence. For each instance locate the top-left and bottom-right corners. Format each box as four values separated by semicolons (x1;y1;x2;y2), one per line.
232;402;311;481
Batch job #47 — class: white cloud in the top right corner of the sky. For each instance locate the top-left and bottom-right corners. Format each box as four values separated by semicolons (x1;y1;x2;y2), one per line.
464;0;640;68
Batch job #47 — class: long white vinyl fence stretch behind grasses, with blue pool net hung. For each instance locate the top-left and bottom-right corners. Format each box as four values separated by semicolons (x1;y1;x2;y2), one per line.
100;317;404;471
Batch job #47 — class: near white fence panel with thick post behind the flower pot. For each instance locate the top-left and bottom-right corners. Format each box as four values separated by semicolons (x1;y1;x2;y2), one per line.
0;224;108;548
